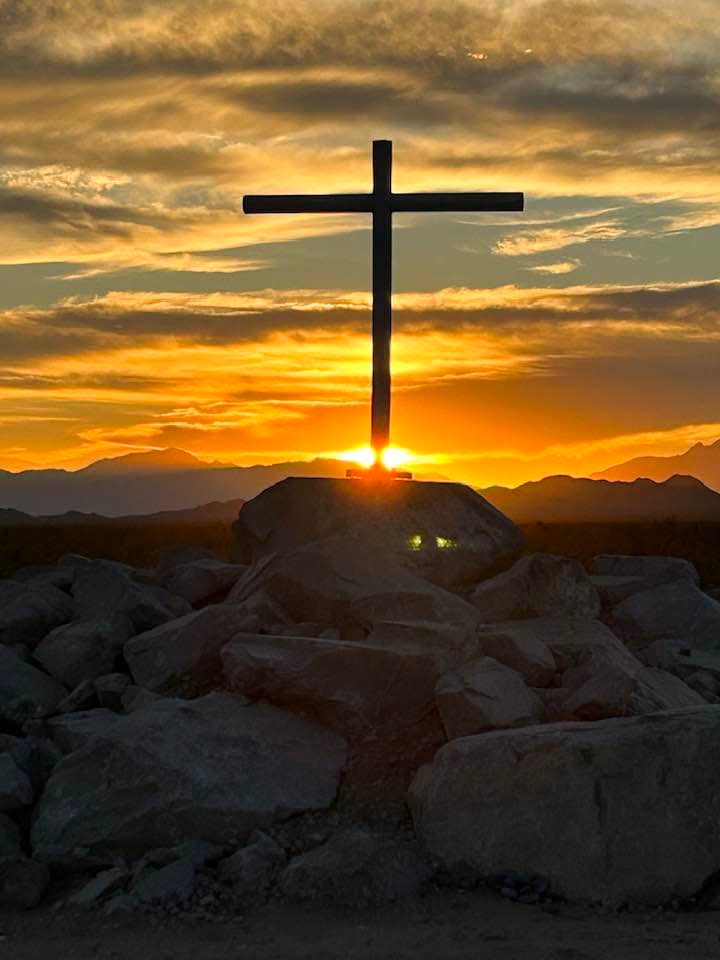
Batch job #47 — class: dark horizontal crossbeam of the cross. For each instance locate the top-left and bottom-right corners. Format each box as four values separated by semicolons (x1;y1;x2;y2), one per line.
243;193;524;213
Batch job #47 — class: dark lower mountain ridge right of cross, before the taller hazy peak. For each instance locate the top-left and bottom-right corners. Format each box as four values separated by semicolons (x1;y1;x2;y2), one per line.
480;468;720;523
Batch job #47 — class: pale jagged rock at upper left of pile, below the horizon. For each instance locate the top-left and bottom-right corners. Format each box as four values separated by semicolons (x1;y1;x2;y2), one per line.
73;558;191;631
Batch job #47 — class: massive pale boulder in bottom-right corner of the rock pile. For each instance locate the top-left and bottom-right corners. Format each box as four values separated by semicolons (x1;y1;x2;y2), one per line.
410;706;720;905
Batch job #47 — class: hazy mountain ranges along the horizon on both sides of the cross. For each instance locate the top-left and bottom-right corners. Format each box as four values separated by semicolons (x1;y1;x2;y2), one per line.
0;441;720;526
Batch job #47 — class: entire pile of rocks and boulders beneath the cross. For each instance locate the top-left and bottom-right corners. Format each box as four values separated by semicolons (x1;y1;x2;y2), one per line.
0;480;720;917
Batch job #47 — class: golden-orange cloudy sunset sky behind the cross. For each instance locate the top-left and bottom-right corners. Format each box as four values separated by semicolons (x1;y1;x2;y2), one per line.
0;0;720;486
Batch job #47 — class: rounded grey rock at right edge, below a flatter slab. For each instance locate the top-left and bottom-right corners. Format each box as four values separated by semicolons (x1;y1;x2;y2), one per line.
613;578;720;653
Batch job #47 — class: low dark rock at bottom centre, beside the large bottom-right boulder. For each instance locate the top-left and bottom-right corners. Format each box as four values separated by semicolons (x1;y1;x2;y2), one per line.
279;828;430;907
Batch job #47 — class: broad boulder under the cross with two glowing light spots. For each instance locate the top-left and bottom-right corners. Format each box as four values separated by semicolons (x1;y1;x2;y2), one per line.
234;477;521;587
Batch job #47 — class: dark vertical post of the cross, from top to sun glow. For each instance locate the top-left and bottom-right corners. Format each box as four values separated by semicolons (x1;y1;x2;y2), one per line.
370;140;392;459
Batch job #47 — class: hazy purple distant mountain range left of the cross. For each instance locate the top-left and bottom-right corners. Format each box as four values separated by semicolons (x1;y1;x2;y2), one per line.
0;449;348;523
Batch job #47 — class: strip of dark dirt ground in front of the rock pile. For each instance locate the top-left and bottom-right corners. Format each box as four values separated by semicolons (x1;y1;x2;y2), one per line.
0;891;720;960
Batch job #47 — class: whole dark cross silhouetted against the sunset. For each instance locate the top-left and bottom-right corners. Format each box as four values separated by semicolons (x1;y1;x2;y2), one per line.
243;140;524;465
